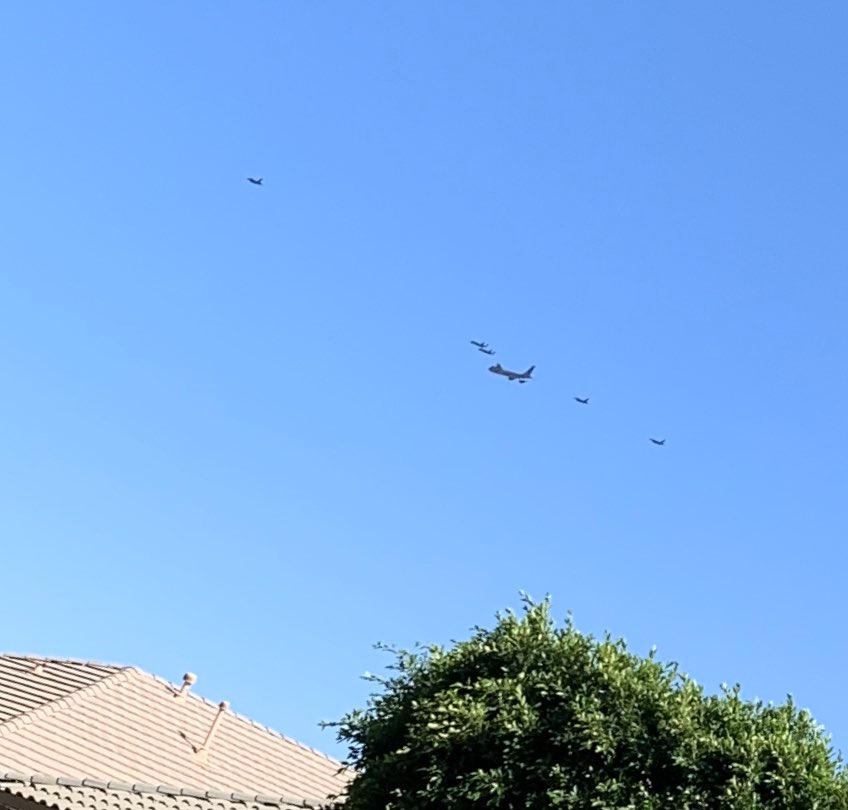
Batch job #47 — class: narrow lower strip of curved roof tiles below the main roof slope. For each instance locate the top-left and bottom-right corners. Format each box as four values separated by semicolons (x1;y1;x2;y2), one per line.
0;773;328;810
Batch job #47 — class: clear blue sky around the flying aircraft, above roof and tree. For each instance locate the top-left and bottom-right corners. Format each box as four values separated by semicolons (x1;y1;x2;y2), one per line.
0;0;848;755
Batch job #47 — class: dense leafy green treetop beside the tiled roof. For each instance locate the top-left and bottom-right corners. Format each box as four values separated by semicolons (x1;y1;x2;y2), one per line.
329;598;848;810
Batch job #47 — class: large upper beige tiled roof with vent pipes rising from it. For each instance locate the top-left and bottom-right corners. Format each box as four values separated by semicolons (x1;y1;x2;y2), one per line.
0;656;349;804
